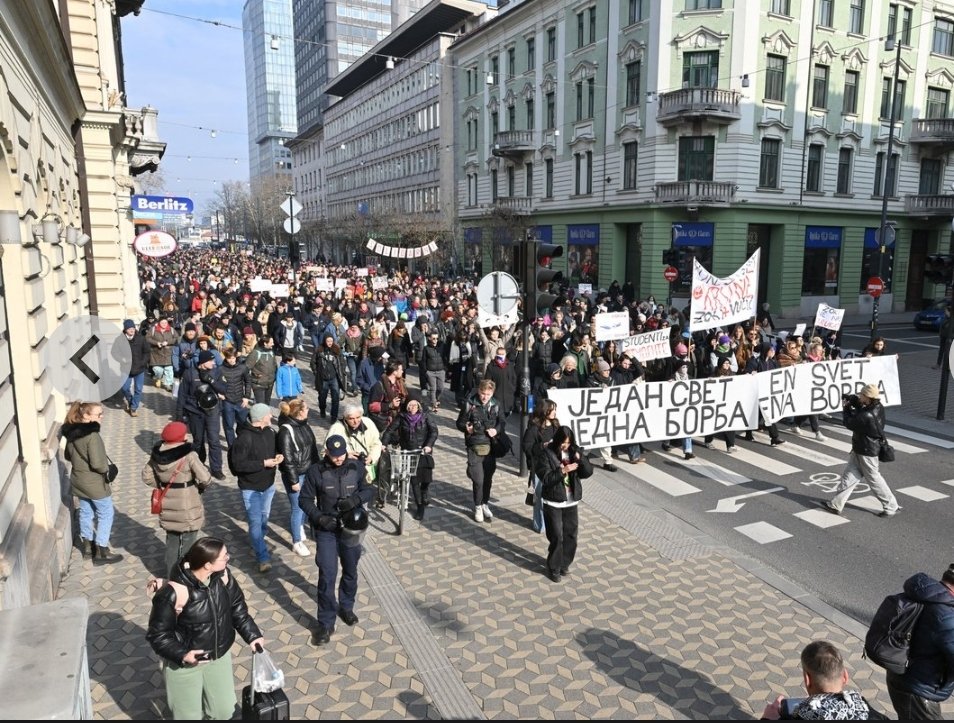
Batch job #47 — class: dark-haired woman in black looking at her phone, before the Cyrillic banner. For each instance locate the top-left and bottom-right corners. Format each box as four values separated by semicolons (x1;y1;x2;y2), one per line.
534;427;593;582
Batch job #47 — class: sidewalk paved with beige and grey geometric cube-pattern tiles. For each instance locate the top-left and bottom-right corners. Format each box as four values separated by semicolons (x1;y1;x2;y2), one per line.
54;376;916;719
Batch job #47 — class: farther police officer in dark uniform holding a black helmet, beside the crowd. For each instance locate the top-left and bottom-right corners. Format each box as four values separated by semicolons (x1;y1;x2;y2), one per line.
179;351;226;481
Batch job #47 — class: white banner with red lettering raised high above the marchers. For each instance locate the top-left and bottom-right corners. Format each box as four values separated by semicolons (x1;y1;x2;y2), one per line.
689;249;761;331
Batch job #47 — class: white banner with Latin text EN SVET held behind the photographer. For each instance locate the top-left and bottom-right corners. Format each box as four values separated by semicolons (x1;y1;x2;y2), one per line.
751;355;901;423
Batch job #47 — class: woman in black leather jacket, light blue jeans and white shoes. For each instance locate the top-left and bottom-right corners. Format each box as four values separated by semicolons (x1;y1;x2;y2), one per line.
278;399;321;557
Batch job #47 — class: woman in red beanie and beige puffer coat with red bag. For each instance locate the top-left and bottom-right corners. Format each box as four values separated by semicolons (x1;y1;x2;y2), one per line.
142;422;212;577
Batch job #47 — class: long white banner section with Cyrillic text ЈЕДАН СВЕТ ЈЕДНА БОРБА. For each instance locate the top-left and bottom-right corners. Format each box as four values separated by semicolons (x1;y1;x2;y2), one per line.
547;374;759;449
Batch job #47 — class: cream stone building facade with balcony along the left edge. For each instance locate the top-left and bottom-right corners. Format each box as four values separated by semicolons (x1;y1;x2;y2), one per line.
0;0;164;609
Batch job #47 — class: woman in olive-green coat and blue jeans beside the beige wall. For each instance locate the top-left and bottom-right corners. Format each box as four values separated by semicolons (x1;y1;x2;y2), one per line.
62;402;123;564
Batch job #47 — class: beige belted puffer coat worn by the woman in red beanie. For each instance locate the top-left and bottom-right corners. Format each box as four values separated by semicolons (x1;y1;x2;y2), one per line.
142;442;212;533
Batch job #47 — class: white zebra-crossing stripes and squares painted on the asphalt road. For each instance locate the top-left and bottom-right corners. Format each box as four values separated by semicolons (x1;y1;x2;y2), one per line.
625;425;954;545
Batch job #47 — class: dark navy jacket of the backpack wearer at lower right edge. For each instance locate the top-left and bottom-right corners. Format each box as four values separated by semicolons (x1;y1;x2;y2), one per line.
887;572;954;701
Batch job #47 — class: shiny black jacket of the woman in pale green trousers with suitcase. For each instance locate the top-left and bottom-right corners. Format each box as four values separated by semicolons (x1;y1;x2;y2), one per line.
146;561;262;666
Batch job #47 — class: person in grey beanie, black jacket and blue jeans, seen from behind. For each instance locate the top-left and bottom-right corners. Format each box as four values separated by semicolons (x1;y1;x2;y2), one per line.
229;403;285;572
